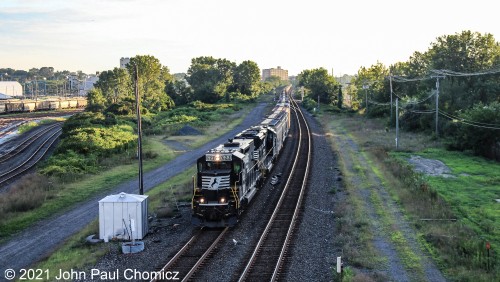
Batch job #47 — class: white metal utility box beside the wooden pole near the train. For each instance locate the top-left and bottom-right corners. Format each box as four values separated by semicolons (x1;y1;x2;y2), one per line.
99;192;148;242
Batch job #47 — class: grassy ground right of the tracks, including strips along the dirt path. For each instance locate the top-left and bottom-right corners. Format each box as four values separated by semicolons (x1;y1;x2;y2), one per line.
320;106;500;281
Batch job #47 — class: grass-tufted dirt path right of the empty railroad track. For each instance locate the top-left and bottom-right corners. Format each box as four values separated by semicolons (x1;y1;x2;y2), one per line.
323;115;446;281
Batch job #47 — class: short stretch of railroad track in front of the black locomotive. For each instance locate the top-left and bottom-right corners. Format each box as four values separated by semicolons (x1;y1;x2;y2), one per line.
151;227;228;281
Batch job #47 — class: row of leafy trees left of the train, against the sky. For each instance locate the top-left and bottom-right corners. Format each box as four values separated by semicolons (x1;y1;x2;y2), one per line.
88;55;282;115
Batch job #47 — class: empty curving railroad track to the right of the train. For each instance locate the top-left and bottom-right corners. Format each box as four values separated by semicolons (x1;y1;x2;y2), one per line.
239;98;311;281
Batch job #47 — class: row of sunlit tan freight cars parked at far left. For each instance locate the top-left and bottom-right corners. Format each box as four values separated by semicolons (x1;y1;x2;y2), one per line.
0;97;87;114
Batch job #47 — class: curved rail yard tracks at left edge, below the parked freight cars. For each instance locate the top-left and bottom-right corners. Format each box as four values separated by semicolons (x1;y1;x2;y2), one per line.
0;123;61;185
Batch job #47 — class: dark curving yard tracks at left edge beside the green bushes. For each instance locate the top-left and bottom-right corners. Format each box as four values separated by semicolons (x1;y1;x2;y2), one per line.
0;122;62;188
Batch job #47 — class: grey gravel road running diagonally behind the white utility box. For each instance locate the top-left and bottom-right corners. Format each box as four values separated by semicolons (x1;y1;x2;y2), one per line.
0;103;267;280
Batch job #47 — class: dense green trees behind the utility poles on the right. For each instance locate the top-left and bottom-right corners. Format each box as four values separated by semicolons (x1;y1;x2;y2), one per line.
299;31;500;160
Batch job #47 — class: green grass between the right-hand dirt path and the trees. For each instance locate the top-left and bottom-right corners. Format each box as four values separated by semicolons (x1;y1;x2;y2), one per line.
322;111;500;281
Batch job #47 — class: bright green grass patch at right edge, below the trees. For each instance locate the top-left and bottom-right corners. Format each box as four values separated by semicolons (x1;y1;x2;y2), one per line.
391;148;500;247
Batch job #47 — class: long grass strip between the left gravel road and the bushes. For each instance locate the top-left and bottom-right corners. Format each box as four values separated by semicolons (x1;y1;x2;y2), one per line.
0;104;253;240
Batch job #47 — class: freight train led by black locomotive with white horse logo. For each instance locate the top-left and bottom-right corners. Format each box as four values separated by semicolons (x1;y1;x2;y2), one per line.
191;93;290;227
